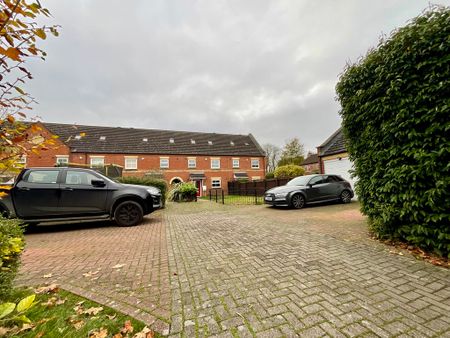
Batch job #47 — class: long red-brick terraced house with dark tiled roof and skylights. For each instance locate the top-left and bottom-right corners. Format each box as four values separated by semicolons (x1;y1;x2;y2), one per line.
23;123;266;195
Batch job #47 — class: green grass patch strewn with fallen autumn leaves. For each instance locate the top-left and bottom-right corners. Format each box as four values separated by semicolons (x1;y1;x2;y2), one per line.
0;289;159;338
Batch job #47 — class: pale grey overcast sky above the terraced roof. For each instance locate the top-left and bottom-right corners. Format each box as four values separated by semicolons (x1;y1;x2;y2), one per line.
27;0;450;149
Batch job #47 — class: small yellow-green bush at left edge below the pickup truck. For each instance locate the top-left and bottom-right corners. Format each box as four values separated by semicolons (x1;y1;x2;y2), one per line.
0;216;25;300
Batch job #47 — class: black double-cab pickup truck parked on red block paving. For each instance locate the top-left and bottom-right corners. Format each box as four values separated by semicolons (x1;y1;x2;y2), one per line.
0;168;162;226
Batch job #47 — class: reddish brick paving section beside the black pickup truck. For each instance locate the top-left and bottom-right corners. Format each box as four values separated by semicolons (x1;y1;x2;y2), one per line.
17;211;170;333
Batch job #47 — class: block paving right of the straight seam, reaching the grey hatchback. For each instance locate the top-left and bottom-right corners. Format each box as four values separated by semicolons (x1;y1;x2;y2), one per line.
166;202;450;337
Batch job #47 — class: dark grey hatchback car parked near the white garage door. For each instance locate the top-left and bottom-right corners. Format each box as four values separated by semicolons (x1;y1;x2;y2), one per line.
264;175;355;209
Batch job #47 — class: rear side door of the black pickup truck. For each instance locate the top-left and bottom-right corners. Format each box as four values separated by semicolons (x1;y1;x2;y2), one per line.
12;169;61;219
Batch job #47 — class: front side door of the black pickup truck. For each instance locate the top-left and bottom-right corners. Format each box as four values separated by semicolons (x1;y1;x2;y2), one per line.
59;169;108;216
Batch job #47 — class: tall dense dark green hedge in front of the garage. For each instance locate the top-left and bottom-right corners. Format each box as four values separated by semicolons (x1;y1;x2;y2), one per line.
336;7;450;256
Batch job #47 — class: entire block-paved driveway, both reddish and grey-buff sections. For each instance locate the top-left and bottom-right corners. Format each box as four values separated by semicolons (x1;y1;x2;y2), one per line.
19;201;450;337
